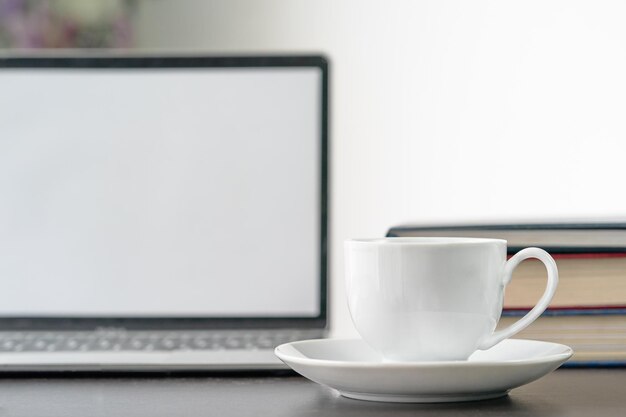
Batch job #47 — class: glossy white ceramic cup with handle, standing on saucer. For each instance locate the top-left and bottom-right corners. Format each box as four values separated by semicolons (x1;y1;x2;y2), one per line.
345;237;558;361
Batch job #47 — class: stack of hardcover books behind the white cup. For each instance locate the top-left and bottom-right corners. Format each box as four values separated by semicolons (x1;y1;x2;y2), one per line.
387;223;626;366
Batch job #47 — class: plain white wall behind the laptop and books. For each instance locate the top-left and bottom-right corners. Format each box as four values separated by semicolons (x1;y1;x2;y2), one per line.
138;0;626;336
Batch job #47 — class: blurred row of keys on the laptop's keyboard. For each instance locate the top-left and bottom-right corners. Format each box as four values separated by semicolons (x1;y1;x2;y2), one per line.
0;331;311;352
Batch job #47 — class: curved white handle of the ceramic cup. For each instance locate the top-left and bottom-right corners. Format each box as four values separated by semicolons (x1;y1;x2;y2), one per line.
478;248;559;350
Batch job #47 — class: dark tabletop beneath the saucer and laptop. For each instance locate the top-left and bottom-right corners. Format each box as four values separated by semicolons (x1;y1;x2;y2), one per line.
0;369;626;417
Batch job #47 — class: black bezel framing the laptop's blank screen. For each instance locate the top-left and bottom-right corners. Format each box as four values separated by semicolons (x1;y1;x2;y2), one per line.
0;55;329;330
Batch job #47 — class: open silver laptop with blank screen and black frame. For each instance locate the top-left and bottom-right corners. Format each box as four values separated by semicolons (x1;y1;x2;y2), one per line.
0;56;328;372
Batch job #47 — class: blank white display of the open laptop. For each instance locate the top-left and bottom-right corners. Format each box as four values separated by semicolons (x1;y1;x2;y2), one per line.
0;68;321;317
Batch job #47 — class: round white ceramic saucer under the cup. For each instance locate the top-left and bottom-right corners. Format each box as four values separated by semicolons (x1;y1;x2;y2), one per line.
275;339;573;403
